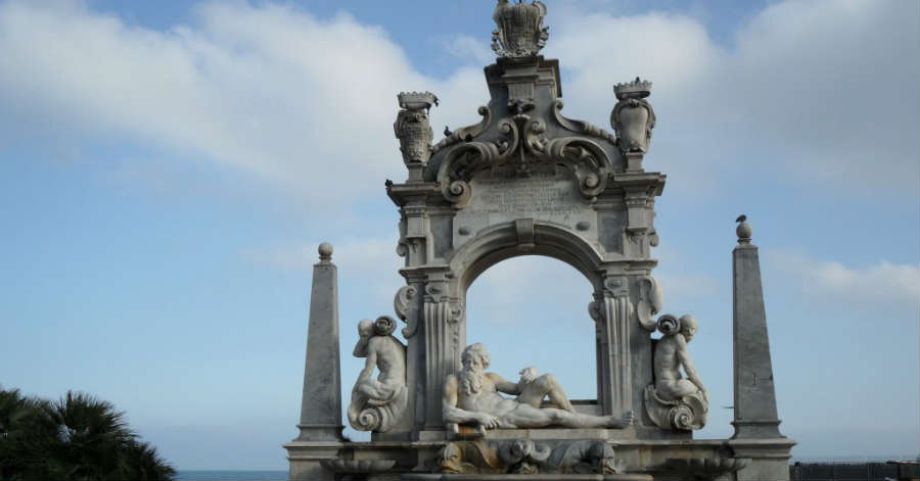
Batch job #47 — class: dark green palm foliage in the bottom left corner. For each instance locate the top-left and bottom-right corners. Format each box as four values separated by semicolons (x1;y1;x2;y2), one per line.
0;388;175;481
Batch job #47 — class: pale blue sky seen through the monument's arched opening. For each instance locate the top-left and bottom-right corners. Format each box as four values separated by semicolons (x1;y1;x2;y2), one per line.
465;255;597;400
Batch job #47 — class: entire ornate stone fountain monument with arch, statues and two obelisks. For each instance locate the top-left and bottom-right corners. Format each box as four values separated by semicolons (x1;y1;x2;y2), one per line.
285;0;795;481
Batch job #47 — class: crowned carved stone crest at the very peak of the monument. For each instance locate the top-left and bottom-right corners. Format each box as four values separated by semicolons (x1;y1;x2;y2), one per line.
492;0;549;58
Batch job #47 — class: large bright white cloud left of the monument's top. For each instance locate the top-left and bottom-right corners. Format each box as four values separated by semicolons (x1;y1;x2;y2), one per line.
0;2;485;212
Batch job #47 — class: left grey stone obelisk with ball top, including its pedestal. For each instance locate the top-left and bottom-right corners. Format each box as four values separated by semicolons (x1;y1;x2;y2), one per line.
284;243;344;481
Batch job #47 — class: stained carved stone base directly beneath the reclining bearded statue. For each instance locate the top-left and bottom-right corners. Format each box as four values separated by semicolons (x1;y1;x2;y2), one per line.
437;439;623;474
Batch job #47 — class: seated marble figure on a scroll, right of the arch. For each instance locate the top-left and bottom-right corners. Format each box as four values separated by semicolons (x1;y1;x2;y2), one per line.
645;314;709;431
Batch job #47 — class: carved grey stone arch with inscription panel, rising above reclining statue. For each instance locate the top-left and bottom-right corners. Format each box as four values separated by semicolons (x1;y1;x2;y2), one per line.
387;56;665;432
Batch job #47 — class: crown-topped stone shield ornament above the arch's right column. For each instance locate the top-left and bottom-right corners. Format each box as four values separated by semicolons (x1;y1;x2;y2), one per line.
610;77;655;153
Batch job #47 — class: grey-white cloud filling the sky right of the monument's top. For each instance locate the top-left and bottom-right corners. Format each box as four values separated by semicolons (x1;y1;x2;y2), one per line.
547;0;920;197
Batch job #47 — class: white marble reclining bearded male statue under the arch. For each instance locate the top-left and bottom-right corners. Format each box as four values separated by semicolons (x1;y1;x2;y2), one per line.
443;343;633;429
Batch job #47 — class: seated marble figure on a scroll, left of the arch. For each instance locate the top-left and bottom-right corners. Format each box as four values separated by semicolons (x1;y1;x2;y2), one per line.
348;316;408;432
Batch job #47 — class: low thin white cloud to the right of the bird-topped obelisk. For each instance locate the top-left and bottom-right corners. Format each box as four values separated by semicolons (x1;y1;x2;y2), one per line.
770;252;920;309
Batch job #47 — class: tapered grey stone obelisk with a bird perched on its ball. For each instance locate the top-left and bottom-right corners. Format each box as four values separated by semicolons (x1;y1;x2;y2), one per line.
732;215;783;439
